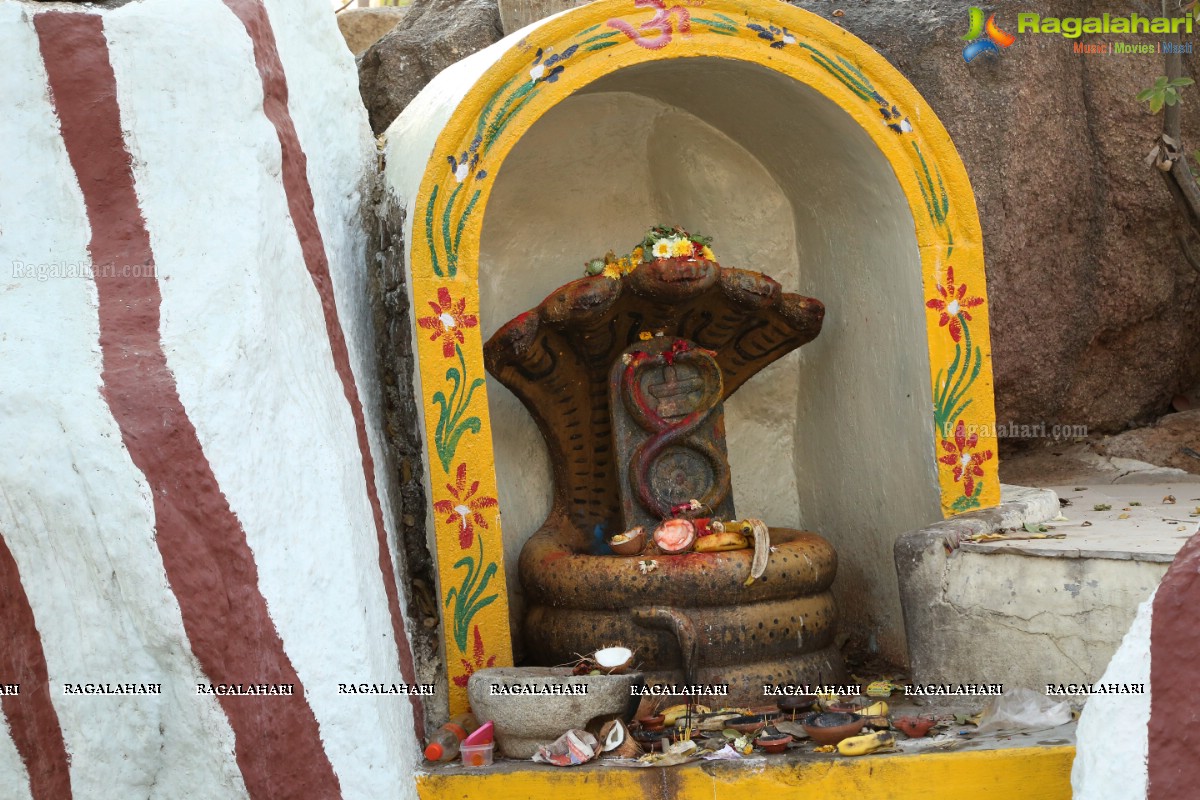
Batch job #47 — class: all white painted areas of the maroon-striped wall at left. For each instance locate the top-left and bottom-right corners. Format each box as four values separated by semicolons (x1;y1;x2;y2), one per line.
0;0;420;800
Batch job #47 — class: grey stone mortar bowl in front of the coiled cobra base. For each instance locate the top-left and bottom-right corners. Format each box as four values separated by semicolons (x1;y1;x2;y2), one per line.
467;667;646;758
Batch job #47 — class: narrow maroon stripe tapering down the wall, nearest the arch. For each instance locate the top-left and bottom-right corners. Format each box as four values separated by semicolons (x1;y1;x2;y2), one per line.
224;0;425;740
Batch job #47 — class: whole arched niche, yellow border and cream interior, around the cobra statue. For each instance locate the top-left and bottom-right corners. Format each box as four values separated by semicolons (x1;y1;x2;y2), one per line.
385;0;1000;708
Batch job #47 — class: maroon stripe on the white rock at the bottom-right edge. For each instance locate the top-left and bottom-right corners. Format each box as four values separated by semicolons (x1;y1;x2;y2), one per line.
1146;534;1200;800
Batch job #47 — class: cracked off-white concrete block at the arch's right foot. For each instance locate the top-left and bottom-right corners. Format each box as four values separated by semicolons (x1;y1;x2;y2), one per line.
895;487;1171;690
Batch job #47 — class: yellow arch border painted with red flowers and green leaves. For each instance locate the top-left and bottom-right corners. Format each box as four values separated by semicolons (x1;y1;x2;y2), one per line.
409;0;1000;710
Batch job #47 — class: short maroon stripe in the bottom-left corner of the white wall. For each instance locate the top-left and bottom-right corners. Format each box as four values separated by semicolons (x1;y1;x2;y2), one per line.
0;536;72;800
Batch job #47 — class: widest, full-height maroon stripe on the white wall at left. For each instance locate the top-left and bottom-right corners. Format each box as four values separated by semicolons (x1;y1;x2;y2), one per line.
34;11;341;800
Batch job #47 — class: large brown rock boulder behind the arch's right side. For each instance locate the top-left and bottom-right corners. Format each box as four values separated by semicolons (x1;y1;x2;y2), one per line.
794;0;1200;444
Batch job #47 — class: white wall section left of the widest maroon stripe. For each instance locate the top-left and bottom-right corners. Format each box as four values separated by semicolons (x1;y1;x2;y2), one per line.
0;4;246;800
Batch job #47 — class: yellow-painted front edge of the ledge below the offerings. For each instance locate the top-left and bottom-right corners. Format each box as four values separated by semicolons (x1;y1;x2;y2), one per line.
416;745;1075;800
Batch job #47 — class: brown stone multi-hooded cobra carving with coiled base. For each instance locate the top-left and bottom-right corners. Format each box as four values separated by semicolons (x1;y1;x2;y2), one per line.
485;259;845;699
